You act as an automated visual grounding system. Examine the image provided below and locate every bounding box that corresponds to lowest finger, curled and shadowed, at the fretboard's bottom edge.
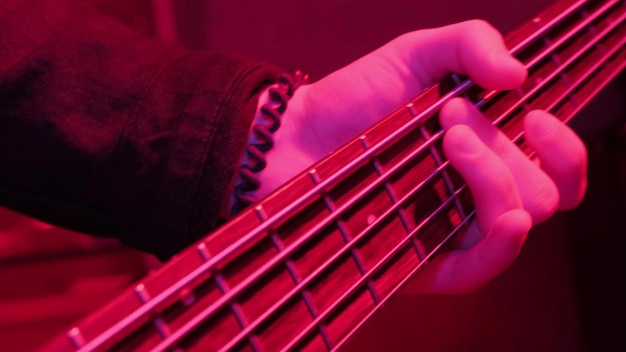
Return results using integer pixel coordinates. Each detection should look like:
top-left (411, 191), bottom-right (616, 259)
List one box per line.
top-left (405, 209), bottom-right (532, 294)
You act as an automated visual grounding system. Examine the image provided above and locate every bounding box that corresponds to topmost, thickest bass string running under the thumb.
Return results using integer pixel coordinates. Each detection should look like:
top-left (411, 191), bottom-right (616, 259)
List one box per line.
top-left (69, 1), bottom-right (615, 351)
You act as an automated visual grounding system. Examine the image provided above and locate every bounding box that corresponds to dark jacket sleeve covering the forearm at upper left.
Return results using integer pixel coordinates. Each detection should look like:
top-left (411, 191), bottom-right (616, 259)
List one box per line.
top-left (0, 0), bottom-right (279, 259)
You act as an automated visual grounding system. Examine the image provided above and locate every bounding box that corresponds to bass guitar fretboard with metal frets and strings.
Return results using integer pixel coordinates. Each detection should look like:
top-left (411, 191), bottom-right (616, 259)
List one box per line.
top-left (46, 0), bottom-right (626, 351)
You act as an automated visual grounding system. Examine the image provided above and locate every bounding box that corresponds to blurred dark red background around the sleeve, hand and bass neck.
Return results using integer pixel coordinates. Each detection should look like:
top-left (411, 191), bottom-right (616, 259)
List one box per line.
top-left (0, 0), bottom-right (626, 351)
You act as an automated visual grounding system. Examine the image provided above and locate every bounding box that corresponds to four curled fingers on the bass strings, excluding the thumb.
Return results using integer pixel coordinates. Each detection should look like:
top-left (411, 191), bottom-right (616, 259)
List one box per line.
top-left (407, 99), bottom-right (587, 293)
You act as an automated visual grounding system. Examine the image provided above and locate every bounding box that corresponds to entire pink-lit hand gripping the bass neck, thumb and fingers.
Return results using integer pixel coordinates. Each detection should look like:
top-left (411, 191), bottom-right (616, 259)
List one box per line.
top-left (252, 21), bottom-right (587, 293)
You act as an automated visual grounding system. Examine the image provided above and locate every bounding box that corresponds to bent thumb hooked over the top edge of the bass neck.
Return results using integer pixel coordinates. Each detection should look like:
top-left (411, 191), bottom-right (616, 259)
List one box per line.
top-left (399, 20), bottom-right (527, 90)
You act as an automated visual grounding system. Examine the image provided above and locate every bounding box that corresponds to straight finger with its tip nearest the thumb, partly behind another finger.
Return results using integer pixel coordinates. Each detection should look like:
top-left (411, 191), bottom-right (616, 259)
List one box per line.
top-left (440, 98), bottom-right (561, 224)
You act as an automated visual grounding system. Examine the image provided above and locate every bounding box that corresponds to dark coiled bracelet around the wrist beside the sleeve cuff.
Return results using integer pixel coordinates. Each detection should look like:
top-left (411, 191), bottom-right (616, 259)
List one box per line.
top-left (230, 70), bottom-right (308, 215)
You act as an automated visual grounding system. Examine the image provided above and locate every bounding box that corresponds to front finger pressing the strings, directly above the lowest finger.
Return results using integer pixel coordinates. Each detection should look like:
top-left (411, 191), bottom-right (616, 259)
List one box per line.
top-left (443, 125), bottom-right (522, 234)
